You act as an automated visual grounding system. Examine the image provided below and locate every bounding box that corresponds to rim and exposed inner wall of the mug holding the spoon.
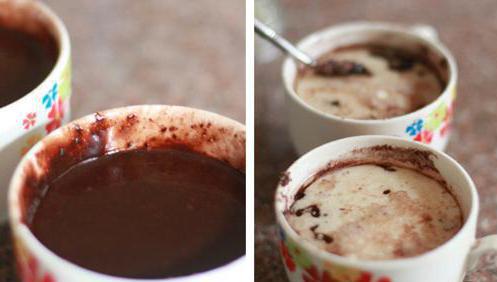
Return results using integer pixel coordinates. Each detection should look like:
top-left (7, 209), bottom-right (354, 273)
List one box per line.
top-left (282, 22), bottom-right (456, 123)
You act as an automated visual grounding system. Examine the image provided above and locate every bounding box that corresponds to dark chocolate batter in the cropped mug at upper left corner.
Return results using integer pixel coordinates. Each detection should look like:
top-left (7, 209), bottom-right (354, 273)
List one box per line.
top-left (0, 26), bottom-right (58, 107)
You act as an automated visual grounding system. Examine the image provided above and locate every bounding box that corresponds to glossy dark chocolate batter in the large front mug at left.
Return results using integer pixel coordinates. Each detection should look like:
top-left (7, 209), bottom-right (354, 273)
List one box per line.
top-left (28, 149), bottom-right (245, 278)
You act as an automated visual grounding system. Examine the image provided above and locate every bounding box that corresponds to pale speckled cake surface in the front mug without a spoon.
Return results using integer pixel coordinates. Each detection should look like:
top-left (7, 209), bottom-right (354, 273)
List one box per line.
top-left (286, 165), bottom-right (462, 260)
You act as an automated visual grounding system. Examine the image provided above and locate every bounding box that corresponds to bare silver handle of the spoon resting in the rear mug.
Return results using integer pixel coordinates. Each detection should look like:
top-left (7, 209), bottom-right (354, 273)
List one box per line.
top-left (254, 19), bottom-right (315, 66)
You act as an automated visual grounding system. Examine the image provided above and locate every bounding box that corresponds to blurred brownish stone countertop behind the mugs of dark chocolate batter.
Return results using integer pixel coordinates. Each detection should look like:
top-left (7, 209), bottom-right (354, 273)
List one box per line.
top-left (0, 0), bottom-right (245, 282)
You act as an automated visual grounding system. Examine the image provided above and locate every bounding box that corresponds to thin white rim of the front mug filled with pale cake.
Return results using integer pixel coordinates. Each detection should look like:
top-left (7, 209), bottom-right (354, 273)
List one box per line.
top-left (274, 135), bottom-right (479, 270)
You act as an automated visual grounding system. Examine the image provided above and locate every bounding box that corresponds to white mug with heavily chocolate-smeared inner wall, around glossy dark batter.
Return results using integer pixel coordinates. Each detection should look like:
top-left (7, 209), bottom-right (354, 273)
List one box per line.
top-left (8, 105), bottom-right (245, 282)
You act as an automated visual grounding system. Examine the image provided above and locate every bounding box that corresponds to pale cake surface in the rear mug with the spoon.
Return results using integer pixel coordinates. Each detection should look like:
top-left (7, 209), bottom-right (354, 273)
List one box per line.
top-left (295, 48), bottom-right (443, 119)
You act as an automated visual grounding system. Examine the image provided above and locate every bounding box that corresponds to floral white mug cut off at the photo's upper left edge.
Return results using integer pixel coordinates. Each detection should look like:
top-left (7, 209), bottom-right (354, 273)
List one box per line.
top-left (0, 0), bottom-right (71, 221)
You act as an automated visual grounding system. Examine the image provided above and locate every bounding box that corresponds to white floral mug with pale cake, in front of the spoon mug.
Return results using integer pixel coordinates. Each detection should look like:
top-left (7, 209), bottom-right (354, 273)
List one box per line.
top-left (275, 136), bottom-right (497, 282)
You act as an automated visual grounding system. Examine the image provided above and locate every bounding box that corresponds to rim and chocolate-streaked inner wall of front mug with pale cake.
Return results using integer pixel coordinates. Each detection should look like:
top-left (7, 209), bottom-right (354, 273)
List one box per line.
top-left (275, 136), bottom-right (478, 267)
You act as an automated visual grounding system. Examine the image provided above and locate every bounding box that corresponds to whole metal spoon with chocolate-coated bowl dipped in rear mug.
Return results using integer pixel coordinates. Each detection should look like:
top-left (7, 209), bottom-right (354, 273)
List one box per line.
top-left (254, 19), bottom-right (371, 76)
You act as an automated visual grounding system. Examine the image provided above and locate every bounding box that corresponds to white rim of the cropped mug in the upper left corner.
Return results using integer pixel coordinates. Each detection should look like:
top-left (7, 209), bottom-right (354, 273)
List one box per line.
top-left (0, 0), bottom-right (71, 112)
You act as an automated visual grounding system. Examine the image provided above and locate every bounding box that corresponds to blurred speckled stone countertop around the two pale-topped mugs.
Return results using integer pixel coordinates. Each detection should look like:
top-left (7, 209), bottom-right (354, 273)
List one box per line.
top-left (255, 0), bottom-right (497, 282)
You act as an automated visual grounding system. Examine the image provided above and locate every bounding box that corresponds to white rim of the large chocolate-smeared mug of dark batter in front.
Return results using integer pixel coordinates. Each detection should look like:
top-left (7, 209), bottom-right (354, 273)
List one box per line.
top-left (7, 104), bottom-right (247, 282)
